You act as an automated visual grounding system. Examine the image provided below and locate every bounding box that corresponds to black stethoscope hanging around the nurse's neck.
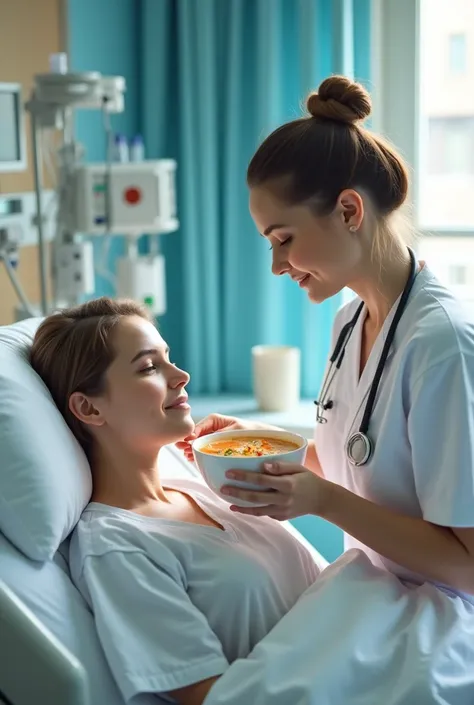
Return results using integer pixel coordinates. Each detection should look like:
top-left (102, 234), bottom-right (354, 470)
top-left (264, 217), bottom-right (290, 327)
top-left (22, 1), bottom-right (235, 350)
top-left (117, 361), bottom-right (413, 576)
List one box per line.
top-left (314, 248), bottom-right (417, 466)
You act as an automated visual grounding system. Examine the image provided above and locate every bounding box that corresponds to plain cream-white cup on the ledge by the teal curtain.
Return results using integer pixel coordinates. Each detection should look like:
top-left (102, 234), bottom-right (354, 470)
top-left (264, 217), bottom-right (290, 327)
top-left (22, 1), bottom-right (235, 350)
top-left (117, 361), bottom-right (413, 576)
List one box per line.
top-left (252, 345), bottom-right (301, 411)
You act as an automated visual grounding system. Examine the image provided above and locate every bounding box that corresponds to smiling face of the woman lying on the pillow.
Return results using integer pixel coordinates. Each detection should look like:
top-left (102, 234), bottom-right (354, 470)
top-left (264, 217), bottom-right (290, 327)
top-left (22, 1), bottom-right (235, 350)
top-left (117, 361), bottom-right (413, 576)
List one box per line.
top-left (90, 316), bottom-right (194, 451)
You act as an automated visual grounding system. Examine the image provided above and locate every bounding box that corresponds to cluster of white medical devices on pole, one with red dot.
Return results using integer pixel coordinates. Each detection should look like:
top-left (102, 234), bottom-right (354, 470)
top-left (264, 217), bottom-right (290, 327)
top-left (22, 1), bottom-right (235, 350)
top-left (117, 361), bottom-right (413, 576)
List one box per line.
top-left (0, 54), bottom-right (179, 319)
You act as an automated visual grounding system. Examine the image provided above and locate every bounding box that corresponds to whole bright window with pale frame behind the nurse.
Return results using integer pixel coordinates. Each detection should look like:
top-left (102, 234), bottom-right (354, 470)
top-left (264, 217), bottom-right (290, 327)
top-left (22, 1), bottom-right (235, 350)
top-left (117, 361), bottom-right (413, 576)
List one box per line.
top-left (372, 0), bottom-right (474, 311)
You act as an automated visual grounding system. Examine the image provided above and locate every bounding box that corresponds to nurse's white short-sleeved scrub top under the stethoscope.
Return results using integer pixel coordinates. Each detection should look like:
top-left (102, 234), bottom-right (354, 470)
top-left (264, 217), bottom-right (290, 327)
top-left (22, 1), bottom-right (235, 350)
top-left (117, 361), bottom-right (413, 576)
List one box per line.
top-left (315, 265), bottom-right (474, 592)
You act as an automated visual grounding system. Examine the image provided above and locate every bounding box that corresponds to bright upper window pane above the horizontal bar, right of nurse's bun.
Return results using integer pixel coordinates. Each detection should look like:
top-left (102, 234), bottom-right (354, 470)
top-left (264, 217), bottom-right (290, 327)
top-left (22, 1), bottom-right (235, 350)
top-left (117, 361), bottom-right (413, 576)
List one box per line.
top-left (416, 0), bottom-right (474, 231)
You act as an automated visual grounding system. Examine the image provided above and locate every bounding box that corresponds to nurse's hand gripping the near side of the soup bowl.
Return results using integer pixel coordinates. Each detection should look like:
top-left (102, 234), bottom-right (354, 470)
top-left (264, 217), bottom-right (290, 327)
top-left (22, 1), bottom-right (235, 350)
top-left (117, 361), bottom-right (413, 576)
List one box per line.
top-left (221, 463), bottom-right (331, 521)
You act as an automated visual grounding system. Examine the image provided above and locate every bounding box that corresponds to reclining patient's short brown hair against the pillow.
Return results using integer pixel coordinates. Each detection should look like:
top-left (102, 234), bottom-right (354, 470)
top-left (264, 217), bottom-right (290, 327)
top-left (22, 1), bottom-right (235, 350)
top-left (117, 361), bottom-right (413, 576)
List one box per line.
top-left (30, 296), bottom-right (150, 459)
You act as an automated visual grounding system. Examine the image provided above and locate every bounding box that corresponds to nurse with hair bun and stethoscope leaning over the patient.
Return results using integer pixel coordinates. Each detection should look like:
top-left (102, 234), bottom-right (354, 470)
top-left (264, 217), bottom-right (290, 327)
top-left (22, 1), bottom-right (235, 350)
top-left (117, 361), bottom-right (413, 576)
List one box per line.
top-left (180, 76), bottom-right (474, 705)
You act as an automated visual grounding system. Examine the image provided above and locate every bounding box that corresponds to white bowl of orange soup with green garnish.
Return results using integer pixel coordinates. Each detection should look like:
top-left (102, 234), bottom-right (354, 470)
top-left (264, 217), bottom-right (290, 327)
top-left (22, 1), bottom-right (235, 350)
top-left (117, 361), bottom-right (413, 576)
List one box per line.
top-left (193, 430), bottom-right (308, 507)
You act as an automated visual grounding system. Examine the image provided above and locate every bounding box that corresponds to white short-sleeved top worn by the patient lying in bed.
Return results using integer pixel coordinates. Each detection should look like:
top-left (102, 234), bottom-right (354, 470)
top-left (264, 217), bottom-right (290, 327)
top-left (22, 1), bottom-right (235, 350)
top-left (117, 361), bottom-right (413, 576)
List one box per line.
top-left (70, 480), bottom-right (319, 702)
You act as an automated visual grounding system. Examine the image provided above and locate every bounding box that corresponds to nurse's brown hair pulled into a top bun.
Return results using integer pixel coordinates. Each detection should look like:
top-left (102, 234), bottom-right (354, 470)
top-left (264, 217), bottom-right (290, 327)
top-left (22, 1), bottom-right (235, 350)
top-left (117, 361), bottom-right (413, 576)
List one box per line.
top-left (247, 76), bottom-right (408, 226)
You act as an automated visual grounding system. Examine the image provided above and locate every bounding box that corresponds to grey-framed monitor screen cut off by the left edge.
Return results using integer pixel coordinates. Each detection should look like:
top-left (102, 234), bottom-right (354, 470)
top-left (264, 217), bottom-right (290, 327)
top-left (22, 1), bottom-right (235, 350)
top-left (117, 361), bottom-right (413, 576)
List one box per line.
top-left (0, 83), bottom-right (26, 172)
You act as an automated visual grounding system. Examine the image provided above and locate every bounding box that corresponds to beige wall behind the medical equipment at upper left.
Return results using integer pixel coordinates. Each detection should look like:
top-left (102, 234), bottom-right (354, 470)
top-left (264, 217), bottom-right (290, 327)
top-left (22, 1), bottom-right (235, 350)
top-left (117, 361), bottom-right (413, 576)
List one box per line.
top-left (0, 0), bottom-right (66, 325)
